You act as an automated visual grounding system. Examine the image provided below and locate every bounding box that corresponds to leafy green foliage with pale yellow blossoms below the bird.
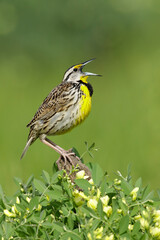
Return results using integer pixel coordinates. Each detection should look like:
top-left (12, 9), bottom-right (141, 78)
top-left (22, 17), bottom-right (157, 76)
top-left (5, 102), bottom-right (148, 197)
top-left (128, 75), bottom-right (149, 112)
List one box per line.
top-left (0, 163), bottom-right (160, 240)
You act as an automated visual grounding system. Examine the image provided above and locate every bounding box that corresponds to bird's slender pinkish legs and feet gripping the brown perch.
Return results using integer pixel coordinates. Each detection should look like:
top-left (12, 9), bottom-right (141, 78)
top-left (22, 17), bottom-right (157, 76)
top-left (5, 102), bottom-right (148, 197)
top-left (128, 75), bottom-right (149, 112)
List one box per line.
top-left (40, 138), bottom-right (75, 165)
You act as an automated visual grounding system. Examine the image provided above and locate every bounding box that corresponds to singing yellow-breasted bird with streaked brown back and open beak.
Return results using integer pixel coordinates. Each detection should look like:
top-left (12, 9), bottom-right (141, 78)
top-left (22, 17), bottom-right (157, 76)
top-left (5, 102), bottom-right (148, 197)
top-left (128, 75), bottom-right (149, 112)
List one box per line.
top-left (20, 59), bottom-right (101, 164)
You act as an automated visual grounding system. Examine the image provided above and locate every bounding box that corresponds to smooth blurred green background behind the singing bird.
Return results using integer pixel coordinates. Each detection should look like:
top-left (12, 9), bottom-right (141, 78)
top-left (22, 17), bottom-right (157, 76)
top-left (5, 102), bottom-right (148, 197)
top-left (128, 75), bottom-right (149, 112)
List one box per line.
top-left (0, 0), bottom-right (160, 194)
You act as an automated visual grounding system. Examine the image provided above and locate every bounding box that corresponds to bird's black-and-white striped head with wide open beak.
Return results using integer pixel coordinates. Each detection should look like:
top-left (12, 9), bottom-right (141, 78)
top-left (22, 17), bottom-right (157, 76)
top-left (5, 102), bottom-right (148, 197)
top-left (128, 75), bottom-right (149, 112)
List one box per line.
top-left (63, 59), bottom-right (101, 83)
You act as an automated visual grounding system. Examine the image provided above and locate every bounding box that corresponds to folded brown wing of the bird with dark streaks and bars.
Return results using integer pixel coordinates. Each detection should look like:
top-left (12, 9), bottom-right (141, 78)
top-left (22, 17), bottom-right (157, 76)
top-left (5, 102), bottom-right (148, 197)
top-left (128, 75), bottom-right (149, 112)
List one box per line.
top-left (27, 82), bottom-right (73, 127)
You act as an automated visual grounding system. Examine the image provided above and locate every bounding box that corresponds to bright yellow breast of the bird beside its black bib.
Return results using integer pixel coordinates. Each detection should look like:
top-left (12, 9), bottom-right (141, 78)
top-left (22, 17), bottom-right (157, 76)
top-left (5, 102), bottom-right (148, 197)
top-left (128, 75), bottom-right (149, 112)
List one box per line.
top-left (78, 85), bottom-right (91, 123)
